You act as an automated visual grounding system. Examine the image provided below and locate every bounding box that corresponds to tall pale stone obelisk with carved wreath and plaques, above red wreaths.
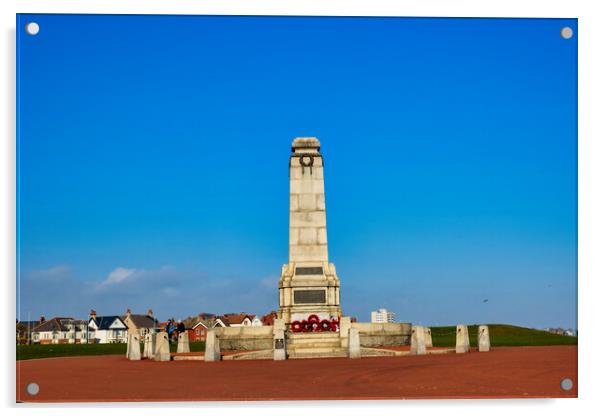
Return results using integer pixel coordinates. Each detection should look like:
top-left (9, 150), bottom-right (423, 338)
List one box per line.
top-left (279, 137), bottom-right (341, 324)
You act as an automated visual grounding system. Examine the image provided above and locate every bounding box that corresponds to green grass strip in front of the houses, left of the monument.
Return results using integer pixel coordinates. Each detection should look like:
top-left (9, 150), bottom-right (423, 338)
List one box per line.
top-left (17, 341), bottom-right (205, 360)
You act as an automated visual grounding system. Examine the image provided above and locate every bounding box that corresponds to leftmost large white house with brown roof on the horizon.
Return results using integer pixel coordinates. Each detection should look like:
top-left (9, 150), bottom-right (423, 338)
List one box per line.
top-left (31, 317), bottom-right (88, 344)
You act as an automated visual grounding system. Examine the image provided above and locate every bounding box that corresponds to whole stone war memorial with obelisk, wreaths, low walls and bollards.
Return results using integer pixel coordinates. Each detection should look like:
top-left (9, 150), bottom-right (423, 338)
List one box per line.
top-left (128, 137), bottom-right (489, 361)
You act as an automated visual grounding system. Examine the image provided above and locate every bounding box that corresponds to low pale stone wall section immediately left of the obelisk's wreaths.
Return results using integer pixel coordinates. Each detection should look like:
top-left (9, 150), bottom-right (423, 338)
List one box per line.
top-left (214, 326), bottom-right (274, 351)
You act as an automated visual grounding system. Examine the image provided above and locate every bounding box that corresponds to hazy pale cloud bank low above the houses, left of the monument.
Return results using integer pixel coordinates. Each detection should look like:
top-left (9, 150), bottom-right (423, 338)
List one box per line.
top-left (19, 265), bottom-right (278, 319)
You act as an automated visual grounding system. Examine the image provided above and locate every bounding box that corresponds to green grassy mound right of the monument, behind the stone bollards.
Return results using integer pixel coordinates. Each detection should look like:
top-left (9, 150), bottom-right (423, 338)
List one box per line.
top-left (431, 324), bottom-right (577, 347)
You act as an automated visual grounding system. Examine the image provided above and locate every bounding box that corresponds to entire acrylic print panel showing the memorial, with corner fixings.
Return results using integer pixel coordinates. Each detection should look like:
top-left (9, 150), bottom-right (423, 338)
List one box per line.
top-left (16, 14), bottom-right (578, 402)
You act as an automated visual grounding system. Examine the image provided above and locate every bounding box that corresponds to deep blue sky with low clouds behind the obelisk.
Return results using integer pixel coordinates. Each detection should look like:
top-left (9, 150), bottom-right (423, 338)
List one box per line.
top-left (17, 15), bottom-right (577, 327)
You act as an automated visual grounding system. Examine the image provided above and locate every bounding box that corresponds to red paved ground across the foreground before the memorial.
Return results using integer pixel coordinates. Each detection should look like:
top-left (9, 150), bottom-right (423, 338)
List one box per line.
top-left (17, 346), bottom-right (577, 402)
